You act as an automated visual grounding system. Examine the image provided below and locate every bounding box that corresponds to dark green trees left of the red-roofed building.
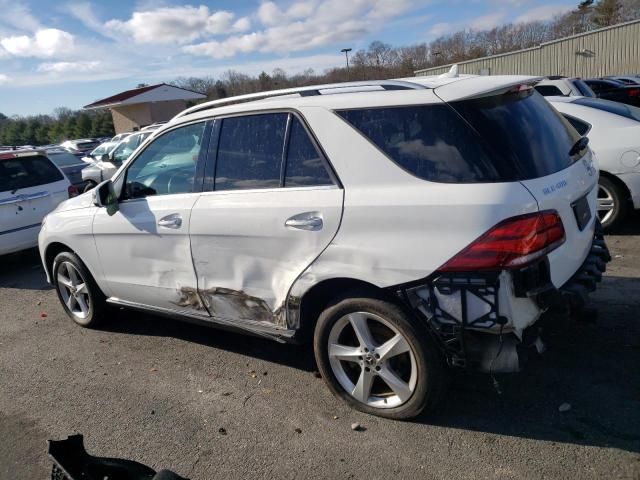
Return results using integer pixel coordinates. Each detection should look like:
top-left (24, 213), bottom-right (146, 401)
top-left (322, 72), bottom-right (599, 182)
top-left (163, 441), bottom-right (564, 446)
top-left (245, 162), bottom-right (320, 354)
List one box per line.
top-left (0, 108), bottom-right (114, 145)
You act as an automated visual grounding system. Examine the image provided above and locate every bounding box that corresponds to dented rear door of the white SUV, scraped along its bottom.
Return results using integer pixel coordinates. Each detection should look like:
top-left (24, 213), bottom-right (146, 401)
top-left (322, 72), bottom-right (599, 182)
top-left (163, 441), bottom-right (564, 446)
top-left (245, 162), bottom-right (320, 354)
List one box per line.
top-left (190, 112), bottom-right (343, 326)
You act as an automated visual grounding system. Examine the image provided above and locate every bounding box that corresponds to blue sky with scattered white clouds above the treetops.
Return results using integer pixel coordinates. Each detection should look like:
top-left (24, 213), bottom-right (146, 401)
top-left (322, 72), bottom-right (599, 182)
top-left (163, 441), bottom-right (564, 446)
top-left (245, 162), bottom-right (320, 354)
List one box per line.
top-left (0, 0), bottom-right (577, 116)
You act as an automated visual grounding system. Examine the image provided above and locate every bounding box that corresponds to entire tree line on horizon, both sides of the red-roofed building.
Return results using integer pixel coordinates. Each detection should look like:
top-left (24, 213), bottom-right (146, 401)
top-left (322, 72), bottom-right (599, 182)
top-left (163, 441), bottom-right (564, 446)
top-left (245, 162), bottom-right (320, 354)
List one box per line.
top-left (0, 0), bottom-right (640, 145)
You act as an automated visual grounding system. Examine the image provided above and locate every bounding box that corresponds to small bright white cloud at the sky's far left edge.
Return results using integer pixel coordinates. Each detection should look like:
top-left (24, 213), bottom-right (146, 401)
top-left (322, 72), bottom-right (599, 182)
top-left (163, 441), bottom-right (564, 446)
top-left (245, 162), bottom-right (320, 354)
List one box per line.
top-left (0, 28), bottom-right (74, 58)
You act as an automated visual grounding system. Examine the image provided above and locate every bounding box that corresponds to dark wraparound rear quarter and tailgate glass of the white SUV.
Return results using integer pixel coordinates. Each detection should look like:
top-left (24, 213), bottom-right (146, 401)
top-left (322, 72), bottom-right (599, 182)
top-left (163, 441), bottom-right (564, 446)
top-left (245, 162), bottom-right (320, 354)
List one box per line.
top-left (337, 89), bottom-right (580, 183)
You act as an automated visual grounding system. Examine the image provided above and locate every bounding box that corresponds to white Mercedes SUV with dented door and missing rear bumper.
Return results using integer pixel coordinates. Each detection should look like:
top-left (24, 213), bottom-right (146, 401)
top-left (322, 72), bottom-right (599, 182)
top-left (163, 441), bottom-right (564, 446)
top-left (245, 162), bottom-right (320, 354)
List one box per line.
top-left (40, 76), bottom-right (609, 418)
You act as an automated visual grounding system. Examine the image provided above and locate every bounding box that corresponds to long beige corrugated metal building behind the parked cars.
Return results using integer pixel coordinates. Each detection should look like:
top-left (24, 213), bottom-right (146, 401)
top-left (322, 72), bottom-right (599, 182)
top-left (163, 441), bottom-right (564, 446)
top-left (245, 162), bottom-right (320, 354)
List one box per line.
top-left (415, 20), bottom-right (640, 78)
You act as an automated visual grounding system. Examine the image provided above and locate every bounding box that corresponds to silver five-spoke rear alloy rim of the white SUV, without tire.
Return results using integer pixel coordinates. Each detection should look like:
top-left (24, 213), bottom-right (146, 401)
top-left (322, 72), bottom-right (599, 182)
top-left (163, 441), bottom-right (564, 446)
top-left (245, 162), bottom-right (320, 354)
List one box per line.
top-left (328, 312), bottom-right (418, 408)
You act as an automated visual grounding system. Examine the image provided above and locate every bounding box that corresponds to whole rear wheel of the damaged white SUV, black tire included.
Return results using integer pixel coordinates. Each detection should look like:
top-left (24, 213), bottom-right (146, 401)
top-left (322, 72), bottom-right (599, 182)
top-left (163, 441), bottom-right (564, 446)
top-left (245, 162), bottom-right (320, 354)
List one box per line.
top-left (313, 292), bottom-right (445, 420)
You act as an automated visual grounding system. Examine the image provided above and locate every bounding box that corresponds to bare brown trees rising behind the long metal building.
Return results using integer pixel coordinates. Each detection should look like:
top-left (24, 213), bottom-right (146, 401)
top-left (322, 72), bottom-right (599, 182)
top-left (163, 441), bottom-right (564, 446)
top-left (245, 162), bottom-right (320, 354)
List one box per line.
top-left (170, 0), bottom-right (640, 100)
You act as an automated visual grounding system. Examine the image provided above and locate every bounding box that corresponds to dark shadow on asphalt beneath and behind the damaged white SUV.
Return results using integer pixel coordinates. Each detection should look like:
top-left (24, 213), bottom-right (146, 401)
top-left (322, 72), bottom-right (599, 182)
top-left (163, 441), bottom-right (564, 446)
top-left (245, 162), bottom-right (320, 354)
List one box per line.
top-left (104, 277), bottom-right (640, 452)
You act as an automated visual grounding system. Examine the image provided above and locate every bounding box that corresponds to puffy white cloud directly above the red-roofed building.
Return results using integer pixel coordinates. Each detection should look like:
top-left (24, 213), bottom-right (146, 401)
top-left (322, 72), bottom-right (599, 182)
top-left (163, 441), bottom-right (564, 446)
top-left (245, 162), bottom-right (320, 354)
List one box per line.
top-left (105, 5), bottom-right (250, 44)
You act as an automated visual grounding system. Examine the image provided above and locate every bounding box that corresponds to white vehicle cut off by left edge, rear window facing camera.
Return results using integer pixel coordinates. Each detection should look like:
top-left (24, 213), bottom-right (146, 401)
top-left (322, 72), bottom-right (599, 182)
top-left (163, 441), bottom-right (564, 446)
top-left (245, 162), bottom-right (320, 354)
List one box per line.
top-left (0, 150), bottom-right (78, 255)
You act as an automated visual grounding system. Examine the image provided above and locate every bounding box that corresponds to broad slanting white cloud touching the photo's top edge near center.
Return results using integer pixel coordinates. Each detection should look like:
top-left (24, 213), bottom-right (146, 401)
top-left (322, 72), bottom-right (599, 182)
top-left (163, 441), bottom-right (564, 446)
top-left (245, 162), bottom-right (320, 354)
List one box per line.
top-left (183, 0), bottom-right (410, 59)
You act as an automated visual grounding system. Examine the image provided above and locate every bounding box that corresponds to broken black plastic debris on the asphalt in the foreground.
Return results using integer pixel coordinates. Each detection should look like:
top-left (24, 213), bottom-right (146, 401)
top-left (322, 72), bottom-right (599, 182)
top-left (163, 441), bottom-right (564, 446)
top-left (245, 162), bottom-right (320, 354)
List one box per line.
top-left (49, 435), bottom-right (188, 480)
